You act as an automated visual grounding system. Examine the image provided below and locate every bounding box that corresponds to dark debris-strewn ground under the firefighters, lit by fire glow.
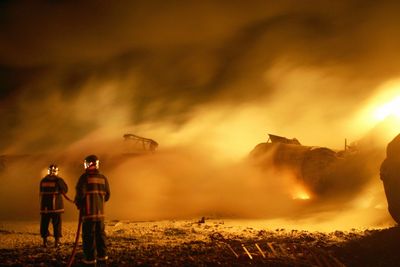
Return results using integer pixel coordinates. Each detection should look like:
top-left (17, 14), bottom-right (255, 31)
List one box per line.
top-left (0, 220), bottom-right (400, 267)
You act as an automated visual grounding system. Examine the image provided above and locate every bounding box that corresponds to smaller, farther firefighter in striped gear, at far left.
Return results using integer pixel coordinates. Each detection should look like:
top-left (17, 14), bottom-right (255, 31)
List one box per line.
top-left (40, 164), bottom-right (68, 247)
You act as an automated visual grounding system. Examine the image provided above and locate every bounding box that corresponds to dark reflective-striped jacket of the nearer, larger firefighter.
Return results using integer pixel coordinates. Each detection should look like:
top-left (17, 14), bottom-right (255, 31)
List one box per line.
top-left (75, 168), bottom-right (110, 221)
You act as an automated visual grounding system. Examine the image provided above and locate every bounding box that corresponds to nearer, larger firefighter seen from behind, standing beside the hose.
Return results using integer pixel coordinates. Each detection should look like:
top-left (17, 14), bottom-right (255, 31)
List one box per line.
top-left (75, 155), bottom-right (110, 265)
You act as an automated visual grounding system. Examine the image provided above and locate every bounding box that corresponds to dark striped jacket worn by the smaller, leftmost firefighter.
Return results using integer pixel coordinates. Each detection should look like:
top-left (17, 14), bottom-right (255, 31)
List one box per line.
top-left (39, 175), bottom-right (68, 214)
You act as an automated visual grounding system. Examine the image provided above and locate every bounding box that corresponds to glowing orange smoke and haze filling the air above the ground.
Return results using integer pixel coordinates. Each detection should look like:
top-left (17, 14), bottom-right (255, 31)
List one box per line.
top-left (0, 0), bottom-right (400, 230)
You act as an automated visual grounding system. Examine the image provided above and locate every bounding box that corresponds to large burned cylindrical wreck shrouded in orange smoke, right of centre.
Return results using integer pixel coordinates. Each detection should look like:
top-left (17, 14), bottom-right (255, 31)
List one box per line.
top-left (250, 134), bottom-right (370, 197)
